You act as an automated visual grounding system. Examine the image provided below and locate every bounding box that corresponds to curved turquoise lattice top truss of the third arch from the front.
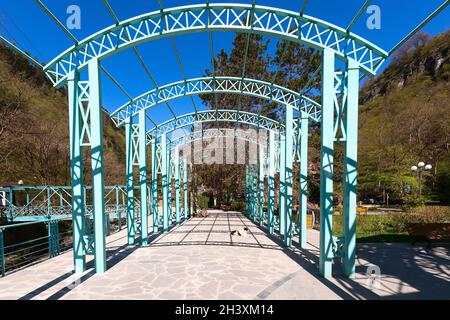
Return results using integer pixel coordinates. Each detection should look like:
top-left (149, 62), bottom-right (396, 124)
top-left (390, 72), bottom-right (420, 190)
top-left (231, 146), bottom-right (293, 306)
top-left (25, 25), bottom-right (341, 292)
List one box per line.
top-left (147, 109), bottom-right (284, 144)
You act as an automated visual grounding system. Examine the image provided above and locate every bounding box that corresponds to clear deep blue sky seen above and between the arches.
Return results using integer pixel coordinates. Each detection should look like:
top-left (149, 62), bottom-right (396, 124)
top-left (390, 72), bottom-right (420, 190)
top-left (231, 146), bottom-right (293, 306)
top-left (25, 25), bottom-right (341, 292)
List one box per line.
top-left (0, 0), bottom-right (450, 126)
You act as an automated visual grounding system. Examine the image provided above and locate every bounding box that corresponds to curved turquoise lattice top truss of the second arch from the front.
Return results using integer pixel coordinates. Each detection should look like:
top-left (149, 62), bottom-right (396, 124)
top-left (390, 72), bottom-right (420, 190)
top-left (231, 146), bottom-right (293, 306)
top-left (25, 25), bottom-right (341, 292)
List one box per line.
top-left (111, 76), bottom-right (320, 126)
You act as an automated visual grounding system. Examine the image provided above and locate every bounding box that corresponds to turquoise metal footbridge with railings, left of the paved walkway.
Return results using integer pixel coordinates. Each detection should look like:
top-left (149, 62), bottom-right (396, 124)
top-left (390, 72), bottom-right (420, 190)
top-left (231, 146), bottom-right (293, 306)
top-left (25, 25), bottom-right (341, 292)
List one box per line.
top-left (0, 186), bottom-right (146, 276)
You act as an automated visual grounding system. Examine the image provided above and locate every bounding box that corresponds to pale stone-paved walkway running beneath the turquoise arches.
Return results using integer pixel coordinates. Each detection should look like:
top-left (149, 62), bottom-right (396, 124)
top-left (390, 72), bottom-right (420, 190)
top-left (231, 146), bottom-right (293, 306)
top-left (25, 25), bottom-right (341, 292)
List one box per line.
top-left (0, 212), bottom-right (450, 299)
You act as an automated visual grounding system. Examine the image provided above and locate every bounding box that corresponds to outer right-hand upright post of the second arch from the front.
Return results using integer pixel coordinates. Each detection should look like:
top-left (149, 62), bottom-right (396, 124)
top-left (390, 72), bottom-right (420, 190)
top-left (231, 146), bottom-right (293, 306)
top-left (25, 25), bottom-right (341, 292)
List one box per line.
top-left (299, 112), bottom-right (309, 248)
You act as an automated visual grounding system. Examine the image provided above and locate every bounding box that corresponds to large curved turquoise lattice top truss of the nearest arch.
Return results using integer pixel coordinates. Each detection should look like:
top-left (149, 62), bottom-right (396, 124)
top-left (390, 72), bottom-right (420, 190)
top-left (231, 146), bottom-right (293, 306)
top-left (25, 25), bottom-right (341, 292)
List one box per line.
top-left (44, 3), bottom-right (388, 86)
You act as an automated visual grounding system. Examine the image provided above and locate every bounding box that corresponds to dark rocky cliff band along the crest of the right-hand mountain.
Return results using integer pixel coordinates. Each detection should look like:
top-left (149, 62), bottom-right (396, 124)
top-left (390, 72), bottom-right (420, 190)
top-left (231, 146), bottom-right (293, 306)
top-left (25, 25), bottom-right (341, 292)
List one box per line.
top-left (360, 31), bottom-right (450, 104)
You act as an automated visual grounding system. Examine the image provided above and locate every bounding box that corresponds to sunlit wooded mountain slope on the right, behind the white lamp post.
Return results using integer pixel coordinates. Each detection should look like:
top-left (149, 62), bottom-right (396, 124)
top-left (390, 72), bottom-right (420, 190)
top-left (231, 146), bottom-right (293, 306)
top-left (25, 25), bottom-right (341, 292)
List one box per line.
top-left (358, 32), bottom-right (450, 200)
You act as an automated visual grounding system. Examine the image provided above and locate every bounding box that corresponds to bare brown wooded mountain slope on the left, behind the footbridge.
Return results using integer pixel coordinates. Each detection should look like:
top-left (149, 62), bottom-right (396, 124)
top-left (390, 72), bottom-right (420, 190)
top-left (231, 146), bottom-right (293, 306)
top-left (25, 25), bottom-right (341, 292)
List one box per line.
top-left (0, 45), bottom-right (125, 185)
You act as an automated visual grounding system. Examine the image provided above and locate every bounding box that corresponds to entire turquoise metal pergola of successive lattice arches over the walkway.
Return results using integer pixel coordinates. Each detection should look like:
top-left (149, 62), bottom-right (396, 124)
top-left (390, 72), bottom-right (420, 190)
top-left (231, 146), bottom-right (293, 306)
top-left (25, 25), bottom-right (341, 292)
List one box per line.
top-left (2, 0), bottom-right (449, 278)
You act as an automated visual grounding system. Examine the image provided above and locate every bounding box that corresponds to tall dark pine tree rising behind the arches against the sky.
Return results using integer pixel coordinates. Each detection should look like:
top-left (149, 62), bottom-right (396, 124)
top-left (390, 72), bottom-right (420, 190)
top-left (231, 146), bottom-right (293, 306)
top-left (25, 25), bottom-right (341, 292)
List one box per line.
top-left (194, 33), bottom-right (320, 208)
